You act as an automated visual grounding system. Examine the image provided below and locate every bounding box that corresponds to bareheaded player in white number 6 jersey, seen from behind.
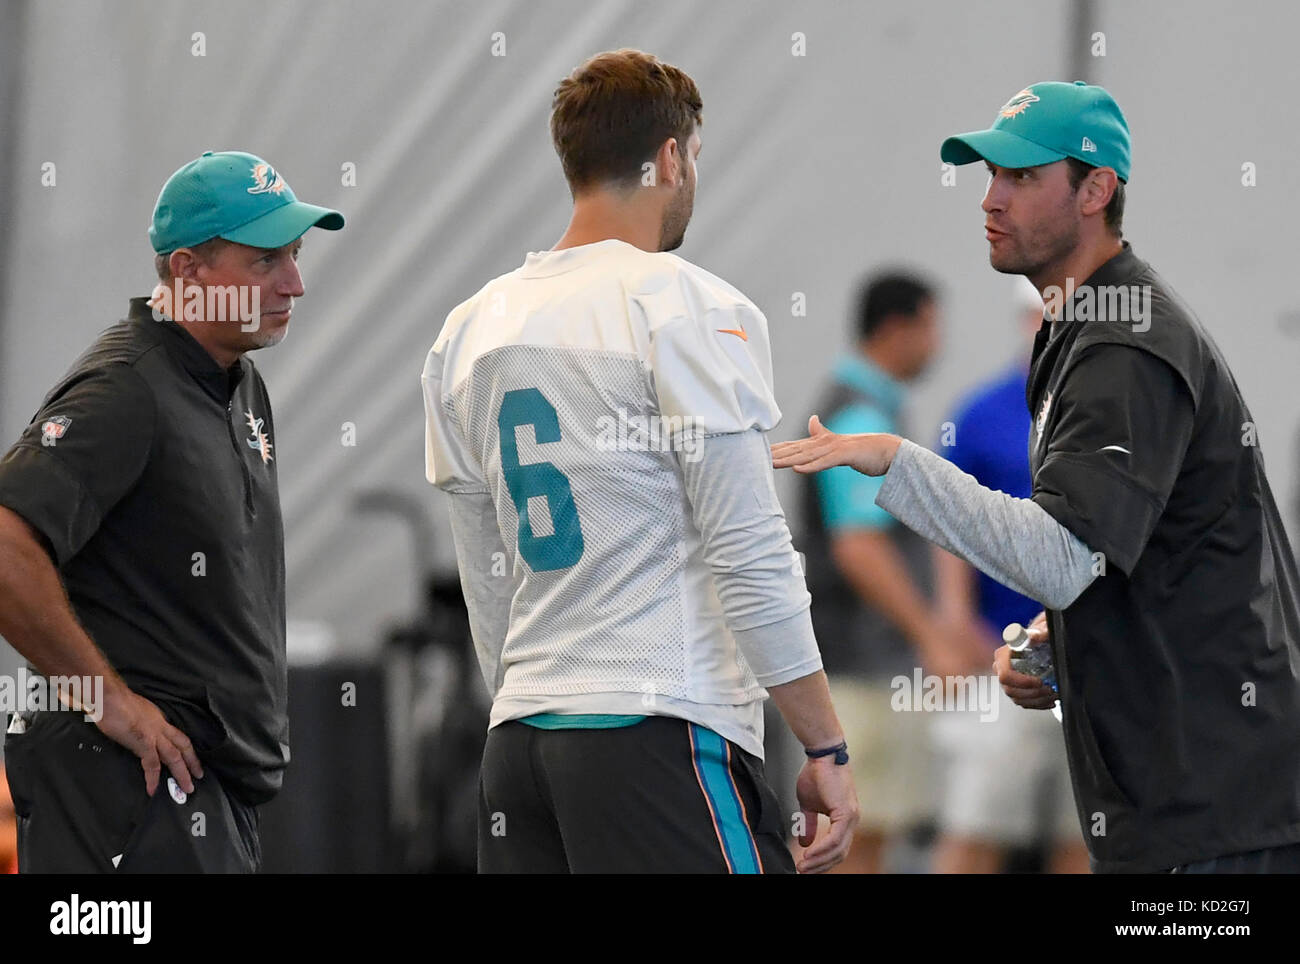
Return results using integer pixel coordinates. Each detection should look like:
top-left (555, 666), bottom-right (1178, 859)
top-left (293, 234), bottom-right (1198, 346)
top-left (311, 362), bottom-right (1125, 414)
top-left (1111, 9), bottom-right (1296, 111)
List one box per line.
top-left (423, 49), bottom-right (858, 873)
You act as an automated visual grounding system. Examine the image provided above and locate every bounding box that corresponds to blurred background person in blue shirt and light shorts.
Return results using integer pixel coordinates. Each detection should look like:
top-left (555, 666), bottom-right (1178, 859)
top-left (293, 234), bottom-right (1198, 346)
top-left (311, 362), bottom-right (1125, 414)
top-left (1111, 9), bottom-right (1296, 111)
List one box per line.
top-left (930, 277), bottom-right (1088, 873)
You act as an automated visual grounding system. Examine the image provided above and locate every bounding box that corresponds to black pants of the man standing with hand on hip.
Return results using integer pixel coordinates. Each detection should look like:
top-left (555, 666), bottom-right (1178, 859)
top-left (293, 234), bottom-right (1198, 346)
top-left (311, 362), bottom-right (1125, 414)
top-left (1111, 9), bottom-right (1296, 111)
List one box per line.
top-left (4, 712), bottom-right (261, 873)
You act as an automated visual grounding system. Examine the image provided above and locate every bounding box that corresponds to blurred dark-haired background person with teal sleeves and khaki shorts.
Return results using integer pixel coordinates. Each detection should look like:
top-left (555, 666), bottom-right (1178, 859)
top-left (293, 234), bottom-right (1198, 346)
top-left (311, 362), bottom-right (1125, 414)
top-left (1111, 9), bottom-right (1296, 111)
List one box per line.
top-left (803, 272), bottom-right (988, 873)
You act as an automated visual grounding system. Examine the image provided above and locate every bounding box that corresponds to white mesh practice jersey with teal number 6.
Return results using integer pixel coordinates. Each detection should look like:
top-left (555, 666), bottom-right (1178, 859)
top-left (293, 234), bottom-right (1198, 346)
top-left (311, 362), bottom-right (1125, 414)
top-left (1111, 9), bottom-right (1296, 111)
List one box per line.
top-left (424, 240), bottom-right (780, 756)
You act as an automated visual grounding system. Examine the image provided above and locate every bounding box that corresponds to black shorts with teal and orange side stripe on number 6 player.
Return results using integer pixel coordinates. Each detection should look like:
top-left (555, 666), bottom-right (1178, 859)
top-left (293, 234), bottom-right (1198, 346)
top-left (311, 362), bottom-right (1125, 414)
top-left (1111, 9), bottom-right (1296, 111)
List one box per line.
top-left (478, 716), bottom-right (794, 873)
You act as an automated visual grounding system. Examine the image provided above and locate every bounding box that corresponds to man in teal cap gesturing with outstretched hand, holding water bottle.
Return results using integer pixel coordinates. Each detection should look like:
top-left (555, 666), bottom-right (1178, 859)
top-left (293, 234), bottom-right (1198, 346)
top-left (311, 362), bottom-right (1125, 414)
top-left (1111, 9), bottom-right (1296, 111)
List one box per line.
top-left (772, 83), bottom-right (1300, 873)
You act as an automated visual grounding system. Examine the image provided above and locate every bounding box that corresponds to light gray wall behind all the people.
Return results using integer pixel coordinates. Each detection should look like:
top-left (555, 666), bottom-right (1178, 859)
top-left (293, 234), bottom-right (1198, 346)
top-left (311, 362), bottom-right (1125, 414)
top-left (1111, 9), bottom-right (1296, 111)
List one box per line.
top-left (0, 0), bottom-right (1300, 665)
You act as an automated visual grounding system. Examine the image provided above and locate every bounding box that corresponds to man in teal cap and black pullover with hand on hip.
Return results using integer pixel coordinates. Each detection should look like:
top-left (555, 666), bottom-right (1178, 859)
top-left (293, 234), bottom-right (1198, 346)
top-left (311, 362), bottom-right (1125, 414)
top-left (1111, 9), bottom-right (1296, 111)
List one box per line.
top-left (0, 152), bottom-right (343, 873)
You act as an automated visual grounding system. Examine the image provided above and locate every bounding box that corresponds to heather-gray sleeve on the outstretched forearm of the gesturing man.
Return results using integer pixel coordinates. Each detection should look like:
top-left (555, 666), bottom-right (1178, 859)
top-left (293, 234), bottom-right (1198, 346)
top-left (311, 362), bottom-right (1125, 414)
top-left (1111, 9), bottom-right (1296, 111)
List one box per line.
top-left (876, 439), bottom-right (1096, 611)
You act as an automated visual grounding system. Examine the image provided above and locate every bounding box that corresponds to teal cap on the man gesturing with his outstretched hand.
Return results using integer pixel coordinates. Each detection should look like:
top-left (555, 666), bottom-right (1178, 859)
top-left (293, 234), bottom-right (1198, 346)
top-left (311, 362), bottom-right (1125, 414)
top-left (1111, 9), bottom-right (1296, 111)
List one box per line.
top-left (939, 81), bottom-right (1131, 183)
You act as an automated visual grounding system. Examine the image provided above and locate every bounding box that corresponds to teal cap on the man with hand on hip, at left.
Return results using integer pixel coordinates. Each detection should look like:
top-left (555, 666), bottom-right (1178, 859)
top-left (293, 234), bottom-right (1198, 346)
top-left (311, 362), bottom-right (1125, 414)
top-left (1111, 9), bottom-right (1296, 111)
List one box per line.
top-left (150, 151), bottom-right (343, 255)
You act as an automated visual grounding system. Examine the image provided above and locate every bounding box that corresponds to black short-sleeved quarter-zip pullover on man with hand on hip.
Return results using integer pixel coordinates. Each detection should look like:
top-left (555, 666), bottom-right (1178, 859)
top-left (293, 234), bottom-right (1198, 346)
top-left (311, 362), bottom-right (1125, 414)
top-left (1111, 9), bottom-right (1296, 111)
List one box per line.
top-left (0, 298), bottom-right (289, 804)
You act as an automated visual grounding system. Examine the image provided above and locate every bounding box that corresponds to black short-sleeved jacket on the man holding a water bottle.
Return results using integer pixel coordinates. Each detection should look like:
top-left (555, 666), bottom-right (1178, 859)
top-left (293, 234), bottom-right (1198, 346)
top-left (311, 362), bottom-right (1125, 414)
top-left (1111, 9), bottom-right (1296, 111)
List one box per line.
top-left (1027, 244), bottom-right (1300, 872)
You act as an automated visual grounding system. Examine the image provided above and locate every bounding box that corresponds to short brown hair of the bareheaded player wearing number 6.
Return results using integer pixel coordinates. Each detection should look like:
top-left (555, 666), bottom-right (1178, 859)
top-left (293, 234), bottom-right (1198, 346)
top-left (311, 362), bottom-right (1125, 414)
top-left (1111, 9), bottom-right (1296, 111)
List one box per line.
top-left (551, 48), bottom-right (703, 194)
